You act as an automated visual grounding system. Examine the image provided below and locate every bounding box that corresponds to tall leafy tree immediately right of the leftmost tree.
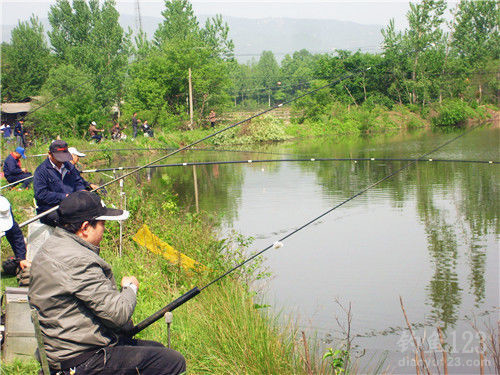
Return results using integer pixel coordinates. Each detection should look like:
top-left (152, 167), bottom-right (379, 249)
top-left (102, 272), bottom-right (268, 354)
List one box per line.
top-left (49, 0), bottom-right (130, 107)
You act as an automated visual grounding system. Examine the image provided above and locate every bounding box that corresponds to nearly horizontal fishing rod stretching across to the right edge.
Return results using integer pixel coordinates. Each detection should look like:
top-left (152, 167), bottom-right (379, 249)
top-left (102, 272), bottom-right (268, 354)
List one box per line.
top-left (81, 158), bottom-right (500, 173)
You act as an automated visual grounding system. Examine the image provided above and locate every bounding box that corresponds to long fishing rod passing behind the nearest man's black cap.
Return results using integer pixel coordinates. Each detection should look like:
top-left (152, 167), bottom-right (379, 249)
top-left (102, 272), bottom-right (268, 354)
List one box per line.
top-left (14, 67), bottom-right (364, 229)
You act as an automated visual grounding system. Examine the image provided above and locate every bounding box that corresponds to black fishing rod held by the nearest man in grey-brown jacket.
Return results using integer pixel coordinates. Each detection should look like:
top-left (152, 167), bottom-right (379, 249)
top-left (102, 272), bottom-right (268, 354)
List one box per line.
top-left (127, 124), bottom-right (480, 336)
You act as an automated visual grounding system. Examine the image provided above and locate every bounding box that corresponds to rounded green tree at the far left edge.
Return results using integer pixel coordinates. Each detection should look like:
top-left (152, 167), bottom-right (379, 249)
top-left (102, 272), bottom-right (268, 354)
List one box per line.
top-left (1, 16), bottom-right (51, 101)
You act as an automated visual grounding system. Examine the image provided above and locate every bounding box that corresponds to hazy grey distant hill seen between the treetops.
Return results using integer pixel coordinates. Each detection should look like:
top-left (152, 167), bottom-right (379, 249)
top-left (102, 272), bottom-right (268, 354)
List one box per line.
top-left (2, 14), bottom-right (382, 62)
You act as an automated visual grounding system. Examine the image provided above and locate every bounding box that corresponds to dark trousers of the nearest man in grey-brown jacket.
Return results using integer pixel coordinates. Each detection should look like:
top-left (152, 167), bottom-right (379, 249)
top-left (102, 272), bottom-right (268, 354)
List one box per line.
top-left (57, 338), bottom-right (186, 375)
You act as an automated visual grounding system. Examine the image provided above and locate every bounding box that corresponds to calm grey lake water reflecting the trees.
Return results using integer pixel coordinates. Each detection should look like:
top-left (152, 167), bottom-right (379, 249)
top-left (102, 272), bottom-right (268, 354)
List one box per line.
top-left (127, 128), bottom-right (500, 373)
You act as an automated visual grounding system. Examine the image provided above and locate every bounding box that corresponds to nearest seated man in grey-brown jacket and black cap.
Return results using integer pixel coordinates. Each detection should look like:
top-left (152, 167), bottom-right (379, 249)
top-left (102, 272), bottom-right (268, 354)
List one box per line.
top-left (28, 191), bottom-right (186, 375)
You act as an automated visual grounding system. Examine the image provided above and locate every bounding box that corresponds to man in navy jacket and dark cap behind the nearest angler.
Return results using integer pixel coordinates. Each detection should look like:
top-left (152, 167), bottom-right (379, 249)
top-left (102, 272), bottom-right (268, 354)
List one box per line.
top-left (33, 140), bottom-right (85, 226)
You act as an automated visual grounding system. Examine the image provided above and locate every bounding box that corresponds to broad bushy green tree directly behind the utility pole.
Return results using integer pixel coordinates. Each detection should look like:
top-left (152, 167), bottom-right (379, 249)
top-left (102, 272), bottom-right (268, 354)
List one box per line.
top-left (127, 0), bottom-right (233, 128)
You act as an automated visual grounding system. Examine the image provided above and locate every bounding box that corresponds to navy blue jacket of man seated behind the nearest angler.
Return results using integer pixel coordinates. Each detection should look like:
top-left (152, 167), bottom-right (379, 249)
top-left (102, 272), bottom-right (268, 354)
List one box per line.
top-left (33, 158), bottom-right (85, 214)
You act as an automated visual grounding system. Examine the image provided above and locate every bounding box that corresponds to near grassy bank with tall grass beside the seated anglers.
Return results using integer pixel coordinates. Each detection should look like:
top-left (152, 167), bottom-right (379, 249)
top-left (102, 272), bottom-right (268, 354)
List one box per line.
top-left (2, 165), bottom-right (316, 374)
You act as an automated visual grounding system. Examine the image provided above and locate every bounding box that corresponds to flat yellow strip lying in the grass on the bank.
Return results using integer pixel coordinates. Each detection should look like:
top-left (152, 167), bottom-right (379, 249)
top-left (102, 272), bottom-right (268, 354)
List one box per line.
top-left (132, 224), bottom-right (205, 270)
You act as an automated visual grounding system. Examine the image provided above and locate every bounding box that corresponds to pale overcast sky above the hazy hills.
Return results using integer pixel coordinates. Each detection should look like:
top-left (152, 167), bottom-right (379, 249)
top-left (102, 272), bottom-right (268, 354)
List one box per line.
top-left (1, 0), bottom-right (455, 29)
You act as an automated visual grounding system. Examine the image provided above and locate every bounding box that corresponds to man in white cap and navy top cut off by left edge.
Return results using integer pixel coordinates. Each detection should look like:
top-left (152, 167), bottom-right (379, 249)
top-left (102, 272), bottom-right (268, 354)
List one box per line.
top-left (0, 196), bottom-right (30, 275)
